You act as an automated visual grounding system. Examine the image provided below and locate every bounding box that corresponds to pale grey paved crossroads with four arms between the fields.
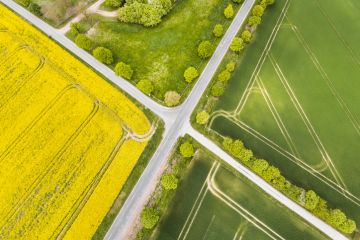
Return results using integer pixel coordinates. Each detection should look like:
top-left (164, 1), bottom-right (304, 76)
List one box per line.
top-left (0, 0), bottom-right (346, 239)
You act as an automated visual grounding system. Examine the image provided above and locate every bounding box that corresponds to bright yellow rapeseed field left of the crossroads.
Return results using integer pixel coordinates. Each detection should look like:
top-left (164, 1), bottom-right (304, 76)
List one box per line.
top-left (0, 4), bottom-right (151, 240)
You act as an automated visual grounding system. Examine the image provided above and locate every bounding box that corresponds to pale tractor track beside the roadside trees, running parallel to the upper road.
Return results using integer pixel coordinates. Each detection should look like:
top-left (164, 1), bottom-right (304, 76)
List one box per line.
top-left (234, 0), bottom-right (291, 115)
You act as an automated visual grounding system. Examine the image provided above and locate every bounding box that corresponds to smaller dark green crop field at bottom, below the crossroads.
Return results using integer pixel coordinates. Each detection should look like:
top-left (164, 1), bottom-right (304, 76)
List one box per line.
top-left (152, 156), bottom-right (326, 240)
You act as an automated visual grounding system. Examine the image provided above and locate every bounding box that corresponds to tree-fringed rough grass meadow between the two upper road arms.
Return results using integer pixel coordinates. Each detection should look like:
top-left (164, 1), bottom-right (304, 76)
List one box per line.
top-left (70, 0), bottom-right (238, 101)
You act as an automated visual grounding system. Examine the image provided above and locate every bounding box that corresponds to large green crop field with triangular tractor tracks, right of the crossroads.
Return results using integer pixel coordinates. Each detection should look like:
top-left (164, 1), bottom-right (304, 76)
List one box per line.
top-left (208, 0), bottom-right (360, 225)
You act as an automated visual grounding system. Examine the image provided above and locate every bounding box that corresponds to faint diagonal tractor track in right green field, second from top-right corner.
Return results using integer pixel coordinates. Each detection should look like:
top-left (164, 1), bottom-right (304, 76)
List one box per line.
top-left (288, 20), bottom-right (360, 136)
